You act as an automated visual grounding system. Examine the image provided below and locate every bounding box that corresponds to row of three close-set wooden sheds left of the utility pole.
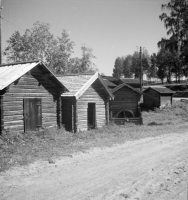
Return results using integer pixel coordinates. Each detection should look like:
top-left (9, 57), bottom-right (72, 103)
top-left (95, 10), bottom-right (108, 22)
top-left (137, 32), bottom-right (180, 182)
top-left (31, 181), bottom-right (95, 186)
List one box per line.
top-left (0, 61), bottom-right (141, 132)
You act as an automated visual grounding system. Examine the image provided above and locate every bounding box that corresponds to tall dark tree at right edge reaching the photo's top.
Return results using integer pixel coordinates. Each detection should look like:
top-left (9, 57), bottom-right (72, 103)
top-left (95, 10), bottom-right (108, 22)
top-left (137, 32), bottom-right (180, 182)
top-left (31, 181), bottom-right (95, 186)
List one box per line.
top-left (159, 0), bottom-right (188, 80)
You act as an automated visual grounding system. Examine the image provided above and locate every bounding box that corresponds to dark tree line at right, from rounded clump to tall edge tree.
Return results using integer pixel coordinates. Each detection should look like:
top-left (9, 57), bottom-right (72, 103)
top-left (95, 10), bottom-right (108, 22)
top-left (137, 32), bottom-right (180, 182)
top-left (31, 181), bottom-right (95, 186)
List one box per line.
top-left (113, 0), bottom-right (188, 83)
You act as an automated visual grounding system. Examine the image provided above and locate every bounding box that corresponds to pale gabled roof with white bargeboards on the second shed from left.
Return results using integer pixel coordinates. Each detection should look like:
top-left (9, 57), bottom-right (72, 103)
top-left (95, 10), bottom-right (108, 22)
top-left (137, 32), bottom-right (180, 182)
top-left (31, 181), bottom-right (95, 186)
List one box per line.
top-left (58, 72), bottom-right (114, 99)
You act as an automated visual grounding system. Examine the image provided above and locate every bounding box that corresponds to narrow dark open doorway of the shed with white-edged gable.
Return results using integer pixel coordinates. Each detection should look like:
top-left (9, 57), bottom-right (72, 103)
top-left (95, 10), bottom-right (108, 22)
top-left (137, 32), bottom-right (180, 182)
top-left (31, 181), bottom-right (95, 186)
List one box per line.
top-left (87, 103), bottom-right (96, 130)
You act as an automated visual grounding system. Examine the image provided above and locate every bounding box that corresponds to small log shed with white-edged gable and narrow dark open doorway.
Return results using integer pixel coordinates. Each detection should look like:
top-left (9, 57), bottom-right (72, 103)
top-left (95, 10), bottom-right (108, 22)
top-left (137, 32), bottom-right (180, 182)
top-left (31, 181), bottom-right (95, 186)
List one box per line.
top-left (59, 73), bottom-right (113, 132)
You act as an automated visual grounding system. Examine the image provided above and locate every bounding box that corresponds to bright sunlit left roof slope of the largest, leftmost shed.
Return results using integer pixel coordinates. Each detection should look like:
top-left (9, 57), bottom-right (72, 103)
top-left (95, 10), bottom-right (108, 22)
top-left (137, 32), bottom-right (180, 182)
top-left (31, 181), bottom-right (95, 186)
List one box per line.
top-left (0, 61), bottom-right (40, 90)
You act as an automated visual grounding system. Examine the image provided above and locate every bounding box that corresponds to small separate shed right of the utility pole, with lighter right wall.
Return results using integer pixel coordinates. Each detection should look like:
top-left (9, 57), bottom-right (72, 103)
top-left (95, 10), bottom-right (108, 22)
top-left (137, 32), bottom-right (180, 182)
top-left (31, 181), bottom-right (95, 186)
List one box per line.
top-left (143, 86), bottom-right (175, 109)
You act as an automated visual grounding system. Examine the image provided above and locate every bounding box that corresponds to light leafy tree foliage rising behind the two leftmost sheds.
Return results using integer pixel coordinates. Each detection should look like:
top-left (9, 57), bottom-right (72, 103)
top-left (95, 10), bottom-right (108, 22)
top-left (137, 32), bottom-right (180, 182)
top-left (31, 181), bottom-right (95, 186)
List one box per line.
top-left (4, 22), bottom-right (96, 74)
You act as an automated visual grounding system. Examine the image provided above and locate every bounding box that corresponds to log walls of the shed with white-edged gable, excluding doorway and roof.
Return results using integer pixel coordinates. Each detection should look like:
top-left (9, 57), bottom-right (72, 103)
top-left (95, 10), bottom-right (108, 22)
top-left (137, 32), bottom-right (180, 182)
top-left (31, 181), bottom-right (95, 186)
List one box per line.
top-left (61, 79), bottom-right (109, 132)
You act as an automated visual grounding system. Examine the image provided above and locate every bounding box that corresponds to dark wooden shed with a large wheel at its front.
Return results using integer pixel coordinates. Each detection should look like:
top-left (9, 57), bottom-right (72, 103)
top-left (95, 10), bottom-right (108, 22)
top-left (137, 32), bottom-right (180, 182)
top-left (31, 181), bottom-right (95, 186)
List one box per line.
top-left (110, 83), bottom-right (142, 124)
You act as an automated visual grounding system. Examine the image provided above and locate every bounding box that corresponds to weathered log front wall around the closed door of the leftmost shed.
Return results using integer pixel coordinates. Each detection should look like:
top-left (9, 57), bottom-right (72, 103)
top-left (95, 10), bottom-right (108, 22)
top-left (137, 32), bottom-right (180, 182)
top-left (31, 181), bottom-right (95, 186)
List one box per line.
top-left (3, 67), bottom-right (58, 131)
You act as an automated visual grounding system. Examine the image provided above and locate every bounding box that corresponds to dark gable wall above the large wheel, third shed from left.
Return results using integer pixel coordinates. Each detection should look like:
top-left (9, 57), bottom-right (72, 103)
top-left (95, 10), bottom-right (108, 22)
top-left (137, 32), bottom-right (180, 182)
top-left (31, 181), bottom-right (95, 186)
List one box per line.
top-left (110, 86), bottom-right (140, 117)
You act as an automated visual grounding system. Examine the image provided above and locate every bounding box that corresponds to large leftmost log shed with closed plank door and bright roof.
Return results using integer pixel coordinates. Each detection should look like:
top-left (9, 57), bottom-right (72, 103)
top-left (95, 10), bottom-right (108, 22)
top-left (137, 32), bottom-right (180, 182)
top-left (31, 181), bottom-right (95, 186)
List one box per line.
top-left (0, 61), bottom-right (66, 132)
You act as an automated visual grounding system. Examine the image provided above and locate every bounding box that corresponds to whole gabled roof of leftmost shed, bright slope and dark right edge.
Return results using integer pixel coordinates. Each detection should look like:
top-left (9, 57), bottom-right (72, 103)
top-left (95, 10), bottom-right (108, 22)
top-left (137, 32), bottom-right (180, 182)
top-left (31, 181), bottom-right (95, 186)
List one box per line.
top-left (0, 61), bottom-right (67, 90)
